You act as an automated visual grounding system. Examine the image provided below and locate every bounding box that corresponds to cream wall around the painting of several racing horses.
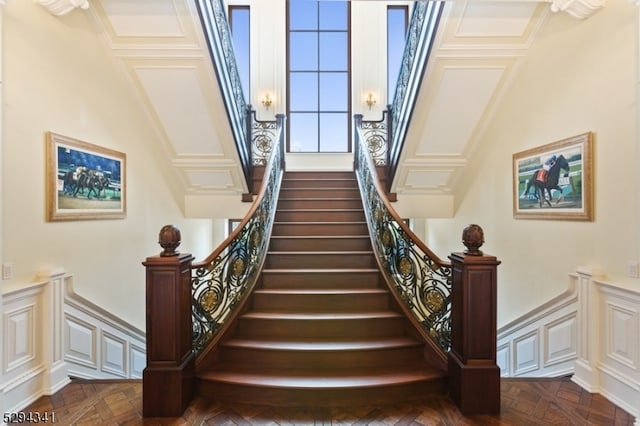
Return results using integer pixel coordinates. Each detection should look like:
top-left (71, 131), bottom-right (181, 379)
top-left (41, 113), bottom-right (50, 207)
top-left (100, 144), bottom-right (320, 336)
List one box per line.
top-left (1, 1), bottom-right (218, 329)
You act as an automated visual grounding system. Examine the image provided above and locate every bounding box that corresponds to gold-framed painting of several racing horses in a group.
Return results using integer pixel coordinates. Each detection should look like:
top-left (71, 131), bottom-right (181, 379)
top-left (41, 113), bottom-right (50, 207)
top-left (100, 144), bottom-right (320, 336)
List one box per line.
top-left (45, 132), bottom-right (127, 221)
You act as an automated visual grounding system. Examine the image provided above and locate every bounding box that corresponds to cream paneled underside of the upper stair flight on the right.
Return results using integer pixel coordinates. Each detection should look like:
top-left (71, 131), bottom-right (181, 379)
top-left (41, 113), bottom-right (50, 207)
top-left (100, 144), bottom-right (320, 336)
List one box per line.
top-left (392, 1), bottom-right (549, 194)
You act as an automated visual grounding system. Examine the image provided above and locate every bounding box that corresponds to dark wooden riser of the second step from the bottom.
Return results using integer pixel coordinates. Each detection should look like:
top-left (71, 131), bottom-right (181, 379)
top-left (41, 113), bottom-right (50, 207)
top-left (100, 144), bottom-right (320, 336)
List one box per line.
top-left (220, 346), bottom-right (422, 369)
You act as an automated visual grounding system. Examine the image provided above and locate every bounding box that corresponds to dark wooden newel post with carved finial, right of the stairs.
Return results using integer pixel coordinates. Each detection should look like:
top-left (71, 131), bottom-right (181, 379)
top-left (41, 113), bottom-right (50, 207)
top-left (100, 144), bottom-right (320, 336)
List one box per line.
top-left (448, 225), bottom-right (500, 414)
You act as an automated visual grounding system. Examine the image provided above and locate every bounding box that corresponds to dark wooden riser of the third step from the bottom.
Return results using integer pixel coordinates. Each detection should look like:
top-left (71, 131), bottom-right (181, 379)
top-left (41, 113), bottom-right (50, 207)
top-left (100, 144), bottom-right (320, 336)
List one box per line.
top-left (237, 317), bottom-right (403, 340)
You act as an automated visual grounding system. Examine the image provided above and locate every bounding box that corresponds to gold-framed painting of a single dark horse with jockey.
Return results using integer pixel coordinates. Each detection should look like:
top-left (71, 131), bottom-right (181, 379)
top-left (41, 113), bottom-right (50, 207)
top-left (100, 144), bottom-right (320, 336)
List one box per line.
top-left (513, 132), bottom-right (593, 221)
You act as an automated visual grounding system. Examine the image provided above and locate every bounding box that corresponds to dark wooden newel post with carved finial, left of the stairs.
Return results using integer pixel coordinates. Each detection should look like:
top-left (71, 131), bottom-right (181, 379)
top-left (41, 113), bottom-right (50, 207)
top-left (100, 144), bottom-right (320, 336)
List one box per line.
top-left (142, 225), bottom-right (194, 417)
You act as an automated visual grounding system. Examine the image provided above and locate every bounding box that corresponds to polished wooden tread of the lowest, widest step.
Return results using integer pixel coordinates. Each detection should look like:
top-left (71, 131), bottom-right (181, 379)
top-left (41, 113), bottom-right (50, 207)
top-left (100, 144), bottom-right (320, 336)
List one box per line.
top-left (198, 363), bottom-right (444, 389)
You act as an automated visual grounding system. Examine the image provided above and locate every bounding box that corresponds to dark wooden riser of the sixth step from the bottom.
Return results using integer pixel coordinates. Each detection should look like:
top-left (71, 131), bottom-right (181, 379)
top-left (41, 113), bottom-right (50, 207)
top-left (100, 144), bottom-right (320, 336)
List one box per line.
top-left (265, 252), bottom-right (377, 269)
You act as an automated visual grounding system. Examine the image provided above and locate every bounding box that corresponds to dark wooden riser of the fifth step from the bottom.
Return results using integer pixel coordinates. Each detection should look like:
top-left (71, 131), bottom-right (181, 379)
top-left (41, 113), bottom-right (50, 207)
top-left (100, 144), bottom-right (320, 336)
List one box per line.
top-left (260, 272), bottom-right (382, 289)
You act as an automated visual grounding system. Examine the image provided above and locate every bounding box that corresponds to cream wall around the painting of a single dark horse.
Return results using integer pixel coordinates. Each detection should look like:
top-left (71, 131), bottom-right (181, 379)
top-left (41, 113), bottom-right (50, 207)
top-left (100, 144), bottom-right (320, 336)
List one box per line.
top-left (427, 0), bottom-right (640, 326)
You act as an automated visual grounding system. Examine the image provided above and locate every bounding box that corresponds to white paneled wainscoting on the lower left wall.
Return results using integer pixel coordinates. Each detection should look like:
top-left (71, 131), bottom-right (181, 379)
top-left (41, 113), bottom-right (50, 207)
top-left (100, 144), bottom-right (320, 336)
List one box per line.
top-left (0, 268), bottom-right (146, 412)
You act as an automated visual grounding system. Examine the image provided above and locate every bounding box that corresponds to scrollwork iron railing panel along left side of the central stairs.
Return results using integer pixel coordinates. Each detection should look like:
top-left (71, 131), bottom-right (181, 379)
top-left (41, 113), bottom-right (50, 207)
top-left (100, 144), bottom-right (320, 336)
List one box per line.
top-left (191, 115), bottom-right (284, 355)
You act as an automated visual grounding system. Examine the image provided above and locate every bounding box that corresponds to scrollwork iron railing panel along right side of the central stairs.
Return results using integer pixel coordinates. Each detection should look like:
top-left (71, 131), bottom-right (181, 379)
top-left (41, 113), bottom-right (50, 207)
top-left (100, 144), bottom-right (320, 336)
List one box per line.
top-left (354, 115), bottom-right (452, 351)
